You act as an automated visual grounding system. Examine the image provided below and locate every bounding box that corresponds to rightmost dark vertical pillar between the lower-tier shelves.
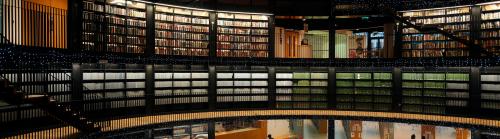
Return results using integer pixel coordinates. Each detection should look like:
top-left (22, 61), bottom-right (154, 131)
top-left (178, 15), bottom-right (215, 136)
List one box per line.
top-left (469, 67), bottom-right (485, 116)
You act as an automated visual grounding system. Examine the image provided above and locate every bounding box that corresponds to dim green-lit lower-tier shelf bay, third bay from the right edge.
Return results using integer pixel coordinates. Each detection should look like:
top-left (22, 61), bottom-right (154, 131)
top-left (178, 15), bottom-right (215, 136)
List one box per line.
top-left (336, 72), bottom-right (392, 111)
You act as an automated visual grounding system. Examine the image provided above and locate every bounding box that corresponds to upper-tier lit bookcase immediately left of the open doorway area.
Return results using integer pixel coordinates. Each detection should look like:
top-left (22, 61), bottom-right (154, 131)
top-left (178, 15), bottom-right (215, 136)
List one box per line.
top-left (217, 12), bottom-right (270, 57)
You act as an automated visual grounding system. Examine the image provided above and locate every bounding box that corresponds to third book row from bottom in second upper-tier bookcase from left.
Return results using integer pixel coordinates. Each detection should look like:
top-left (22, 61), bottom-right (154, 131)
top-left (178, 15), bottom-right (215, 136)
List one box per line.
top-left (155, 31), bottom-right (208, 41)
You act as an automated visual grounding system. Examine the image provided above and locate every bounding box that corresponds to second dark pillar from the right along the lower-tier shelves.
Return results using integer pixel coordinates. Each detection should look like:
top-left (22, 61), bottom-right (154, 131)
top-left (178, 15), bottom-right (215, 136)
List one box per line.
top-left (392, 67), bottom-right (403, 112)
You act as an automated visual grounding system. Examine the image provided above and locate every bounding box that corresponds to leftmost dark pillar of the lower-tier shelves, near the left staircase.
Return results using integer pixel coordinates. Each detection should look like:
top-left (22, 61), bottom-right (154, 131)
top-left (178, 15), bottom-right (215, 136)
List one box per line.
top-left (71, 63), bottom-right (83, 109)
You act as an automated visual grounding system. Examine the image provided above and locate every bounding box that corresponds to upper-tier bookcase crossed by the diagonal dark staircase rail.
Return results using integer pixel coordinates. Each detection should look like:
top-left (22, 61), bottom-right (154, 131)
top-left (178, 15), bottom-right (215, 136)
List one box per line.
top-left (401, 7), bottom-right (471, 57)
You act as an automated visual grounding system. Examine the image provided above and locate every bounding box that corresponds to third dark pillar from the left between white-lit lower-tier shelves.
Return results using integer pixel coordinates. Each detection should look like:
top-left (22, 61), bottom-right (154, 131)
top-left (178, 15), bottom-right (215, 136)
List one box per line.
top-left (208, 66), bottom-right (217, 110)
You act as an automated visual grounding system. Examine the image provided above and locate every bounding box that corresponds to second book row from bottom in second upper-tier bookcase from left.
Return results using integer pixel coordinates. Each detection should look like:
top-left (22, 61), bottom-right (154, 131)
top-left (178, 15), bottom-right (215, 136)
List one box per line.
top-left (155, 39), bottom-right (208, 48)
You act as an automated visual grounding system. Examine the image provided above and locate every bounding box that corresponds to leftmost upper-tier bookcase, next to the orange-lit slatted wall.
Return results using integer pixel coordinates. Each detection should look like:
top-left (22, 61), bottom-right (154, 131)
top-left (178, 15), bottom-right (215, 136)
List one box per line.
top-left (82, 0), bottom-right (146, 53)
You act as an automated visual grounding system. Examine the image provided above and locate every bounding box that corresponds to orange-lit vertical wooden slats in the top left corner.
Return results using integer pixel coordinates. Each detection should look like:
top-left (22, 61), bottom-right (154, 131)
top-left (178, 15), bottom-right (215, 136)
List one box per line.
top-left (1, 0), bottom-right (67, 49)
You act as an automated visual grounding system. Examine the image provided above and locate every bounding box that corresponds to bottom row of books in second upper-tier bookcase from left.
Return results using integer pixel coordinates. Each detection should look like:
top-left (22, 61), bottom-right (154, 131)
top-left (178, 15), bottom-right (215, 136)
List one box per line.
top-left (155, 47), bottom-right (208, 56)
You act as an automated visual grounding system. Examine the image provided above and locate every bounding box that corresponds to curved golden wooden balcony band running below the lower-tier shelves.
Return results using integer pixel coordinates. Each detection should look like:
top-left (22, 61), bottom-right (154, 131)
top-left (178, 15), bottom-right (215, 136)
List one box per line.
top-left (6, 110), bottom-right (500, 138)
